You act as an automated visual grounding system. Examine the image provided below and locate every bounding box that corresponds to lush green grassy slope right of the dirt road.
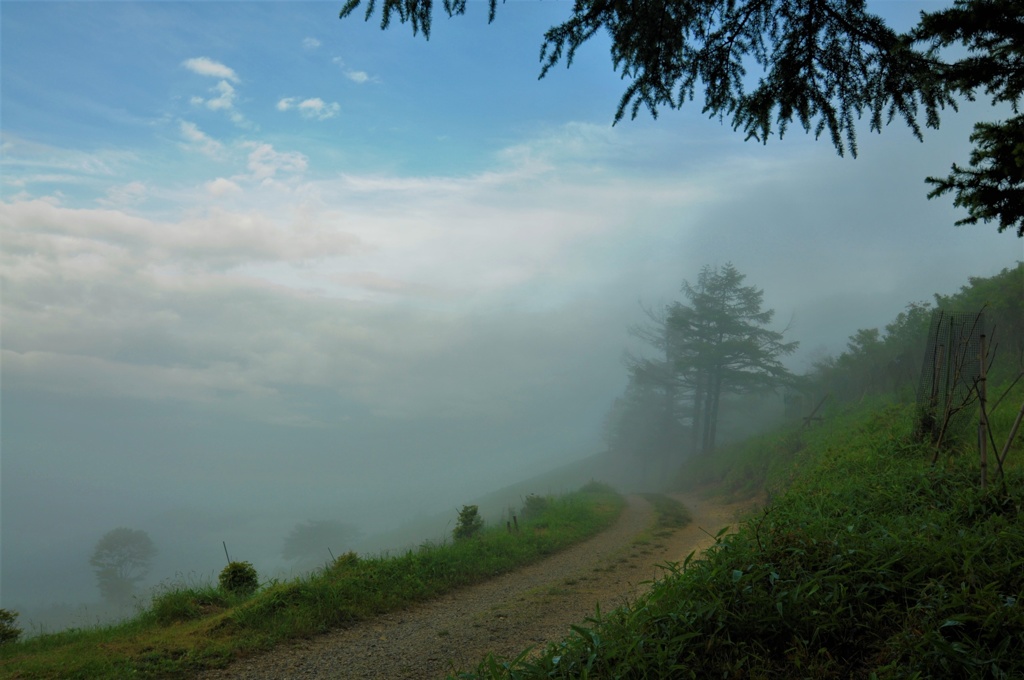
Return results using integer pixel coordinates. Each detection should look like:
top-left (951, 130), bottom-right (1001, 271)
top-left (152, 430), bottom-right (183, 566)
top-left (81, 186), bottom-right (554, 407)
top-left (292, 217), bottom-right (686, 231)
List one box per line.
top-left (459, 401), bottom-right (1024, 680)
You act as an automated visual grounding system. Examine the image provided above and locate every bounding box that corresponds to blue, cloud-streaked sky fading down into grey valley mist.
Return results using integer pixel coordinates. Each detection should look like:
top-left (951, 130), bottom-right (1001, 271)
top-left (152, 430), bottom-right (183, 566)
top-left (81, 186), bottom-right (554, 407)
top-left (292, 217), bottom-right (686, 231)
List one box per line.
top-left (0, 0), bottom-right (1024, 605)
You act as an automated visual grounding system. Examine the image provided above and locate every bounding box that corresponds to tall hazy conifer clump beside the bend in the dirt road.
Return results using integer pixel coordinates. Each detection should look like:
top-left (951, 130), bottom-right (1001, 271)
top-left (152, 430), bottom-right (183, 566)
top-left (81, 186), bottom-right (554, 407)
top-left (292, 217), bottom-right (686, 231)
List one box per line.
top-left (605, 263), bottom-right (798, 460)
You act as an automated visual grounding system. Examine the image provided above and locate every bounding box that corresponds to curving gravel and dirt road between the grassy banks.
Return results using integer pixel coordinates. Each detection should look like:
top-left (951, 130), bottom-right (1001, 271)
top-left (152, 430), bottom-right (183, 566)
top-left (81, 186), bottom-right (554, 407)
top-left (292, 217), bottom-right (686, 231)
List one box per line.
top-left (200, 495), bottom-right (759, 680)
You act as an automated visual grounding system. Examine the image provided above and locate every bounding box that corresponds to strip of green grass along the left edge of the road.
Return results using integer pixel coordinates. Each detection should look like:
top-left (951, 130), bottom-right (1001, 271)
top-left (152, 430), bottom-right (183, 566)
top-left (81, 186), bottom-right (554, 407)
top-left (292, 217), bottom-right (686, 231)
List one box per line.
top-left (0, 483), bottom-right (625, 680)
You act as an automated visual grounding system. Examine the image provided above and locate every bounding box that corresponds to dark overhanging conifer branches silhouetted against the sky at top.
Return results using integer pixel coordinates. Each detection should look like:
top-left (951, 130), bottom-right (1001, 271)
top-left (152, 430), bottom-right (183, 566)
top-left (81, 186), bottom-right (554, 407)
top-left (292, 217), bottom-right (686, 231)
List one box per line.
top-left (340, 0), bottom-right (1024, 237)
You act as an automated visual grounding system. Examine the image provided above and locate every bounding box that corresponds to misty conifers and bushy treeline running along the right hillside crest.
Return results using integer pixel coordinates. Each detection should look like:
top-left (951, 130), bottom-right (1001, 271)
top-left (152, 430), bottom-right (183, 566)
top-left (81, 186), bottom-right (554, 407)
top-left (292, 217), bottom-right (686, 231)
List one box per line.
top-left (604, 263), bottom-right (1024, 484)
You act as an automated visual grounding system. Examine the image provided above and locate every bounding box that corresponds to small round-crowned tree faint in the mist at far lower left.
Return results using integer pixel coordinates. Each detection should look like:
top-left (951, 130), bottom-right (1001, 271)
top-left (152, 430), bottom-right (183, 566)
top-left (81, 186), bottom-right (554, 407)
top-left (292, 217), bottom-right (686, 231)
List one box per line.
top-left (89, 526), bottom-right (157, 606)
